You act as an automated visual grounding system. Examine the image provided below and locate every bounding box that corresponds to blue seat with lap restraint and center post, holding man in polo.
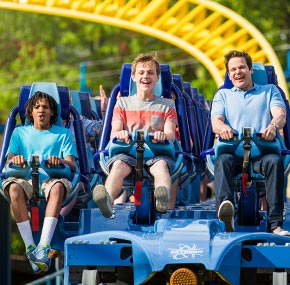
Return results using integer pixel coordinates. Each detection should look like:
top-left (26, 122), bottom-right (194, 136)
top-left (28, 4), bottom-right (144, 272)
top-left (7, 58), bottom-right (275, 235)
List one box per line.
top-left (201, 63), bottom-right (290, 231)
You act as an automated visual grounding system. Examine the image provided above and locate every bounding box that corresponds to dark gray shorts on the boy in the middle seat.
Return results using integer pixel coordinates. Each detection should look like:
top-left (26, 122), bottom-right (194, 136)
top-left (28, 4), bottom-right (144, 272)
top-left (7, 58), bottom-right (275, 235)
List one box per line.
top-left (107, 153), bottom-right (175, 173)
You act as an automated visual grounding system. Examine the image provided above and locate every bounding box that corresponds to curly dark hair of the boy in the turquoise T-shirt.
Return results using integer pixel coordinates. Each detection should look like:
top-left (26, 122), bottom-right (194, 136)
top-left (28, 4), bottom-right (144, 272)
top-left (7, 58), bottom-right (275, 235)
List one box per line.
top-left (25, 91), bottom-right (58, 124)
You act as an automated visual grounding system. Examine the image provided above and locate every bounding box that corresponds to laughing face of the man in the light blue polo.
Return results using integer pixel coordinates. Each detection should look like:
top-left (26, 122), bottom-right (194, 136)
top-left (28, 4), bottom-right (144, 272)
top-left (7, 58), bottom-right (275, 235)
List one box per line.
top-left (228, 57), bottom-right (253, 91)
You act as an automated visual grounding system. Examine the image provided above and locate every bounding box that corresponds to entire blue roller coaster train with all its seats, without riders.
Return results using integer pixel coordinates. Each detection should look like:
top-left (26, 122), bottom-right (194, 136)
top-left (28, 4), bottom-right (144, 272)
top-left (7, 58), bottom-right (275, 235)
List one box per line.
top-left (0, 63), bottom-right (290, 285)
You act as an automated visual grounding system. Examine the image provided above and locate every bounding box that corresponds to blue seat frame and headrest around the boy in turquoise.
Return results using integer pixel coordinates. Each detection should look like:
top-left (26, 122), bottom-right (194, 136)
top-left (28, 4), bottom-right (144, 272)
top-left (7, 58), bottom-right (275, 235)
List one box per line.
top-left (0, 82), bottom-right (89, 250)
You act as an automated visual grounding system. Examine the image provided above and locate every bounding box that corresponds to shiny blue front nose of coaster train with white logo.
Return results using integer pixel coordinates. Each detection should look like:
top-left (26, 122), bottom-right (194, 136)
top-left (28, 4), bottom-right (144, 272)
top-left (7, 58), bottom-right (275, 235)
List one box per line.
top-left (64, 62), bottom-right (290, 285)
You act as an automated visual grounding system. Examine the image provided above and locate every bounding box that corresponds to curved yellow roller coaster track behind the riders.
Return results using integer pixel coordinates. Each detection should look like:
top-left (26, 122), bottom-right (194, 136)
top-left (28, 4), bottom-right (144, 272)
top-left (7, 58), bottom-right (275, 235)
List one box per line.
top-left (0, 0), bottom-right (288, 98)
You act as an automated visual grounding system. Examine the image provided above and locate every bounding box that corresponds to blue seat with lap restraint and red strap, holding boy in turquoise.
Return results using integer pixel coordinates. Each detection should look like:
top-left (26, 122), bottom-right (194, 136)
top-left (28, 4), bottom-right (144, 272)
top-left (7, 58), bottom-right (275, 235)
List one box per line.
top-left (0, 82), bottom-right (90, 250)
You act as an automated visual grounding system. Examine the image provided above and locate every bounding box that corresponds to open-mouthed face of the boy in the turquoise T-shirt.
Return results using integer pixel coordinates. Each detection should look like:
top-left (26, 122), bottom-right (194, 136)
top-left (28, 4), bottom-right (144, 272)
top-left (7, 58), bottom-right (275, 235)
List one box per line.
top-left (31, 98), bottom-right (53, 130)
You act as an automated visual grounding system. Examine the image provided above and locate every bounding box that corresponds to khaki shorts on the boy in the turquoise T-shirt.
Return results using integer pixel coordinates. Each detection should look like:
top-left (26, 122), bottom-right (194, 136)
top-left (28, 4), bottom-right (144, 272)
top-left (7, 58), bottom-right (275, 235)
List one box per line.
top-left (3, 177), bottom-right (72, 200)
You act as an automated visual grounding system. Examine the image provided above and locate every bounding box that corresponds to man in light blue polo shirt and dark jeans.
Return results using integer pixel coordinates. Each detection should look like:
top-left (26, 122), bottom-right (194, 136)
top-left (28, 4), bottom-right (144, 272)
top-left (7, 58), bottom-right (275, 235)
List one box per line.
top-left (211, 50), bottom-right (290, 236)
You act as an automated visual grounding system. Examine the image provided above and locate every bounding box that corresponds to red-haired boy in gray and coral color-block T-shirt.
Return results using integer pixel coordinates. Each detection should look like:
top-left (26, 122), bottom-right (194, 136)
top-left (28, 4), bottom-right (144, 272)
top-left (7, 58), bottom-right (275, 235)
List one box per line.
top-left (93, 53), bottom-right (177, 218)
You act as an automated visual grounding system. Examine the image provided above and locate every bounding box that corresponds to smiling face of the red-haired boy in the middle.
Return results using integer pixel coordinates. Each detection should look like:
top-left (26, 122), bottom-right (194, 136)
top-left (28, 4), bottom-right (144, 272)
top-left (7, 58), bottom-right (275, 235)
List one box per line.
top-left (132, 61), bottom-right (159, 95)
